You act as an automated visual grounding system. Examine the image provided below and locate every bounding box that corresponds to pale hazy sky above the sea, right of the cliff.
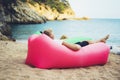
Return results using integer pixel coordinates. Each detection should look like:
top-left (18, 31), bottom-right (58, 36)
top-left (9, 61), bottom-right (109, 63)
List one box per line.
top-left (68, 0), bottom-right (120, 18)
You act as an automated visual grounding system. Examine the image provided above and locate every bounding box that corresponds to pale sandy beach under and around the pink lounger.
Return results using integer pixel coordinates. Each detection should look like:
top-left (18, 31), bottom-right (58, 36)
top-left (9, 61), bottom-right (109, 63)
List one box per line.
top-left (0, 41), bottom-right (120, 80)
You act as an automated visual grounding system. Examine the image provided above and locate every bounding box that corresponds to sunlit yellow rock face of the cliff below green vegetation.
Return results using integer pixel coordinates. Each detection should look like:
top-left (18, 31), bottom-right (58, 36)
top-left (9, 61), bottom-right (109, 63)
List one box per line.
top-left (28, 3), bottom-right (75, 20)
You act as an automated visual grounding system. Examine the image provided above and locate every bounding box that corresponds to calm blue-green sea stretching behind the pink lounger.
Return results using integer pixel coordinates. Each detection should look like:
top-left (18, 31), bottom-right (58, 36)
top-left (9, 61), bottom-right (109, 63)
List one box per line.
top-left (11, 19), bottom-right (120, 46)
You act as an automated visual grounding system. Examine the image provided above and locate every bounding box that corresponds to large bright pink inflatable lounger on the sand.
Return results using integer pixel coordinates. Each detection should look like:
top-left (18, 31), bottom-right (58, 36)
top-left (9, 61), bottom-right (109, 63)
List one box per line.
top-left (25, 34), bottom-right (110, 69)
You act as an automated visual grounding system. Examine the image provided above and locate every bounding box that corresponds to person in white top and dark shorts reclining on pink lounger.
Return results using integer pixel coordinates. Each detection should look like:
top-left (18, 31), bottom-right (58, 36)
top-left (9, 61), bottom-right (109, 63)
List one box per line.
top-left (41, 29), bottom-right (109, 51)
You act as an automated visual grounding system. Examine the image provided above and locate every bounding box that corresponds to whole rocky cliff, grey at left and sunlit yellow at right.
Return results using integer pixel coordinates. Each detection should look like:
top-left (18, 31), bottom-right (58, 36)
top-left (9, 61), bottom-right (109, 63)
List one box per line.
top-left (0, 0), bottom-right (75, 39)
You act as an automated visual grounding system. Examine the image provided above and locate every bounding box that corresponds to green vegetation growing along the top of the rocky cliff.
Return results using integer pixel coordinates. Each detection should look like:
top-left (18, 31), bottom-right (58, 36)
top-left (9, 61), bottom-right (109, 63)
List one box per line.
top-left (3, 0), bottom-right (70, 13)
